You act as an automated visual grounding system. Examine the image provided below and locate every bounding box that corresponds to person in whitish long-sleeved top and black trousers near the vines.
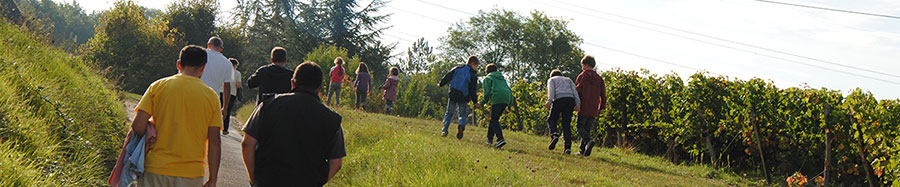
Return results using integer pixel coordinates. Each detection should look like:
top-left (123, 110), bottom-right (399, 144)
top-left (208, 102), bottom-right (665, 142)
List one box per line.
top-left (544, 69), bottom-right (581, 154)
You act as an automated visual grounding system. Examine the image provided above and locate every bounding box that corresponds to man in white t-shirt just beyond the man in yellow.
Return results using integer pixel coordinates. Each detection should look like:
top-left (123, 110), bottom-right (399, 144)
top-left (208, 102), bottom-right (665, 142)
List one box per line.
top-left (200, 36), bottom-right (234, 135)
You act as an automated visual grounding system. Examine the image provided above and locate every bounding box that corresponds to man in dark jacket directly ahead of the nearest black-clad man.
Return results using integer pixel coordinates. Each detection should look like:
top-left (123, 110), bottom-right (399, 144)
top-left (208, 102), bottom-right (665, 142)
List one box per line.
top-left (247, 47), bottom-right (294, 104)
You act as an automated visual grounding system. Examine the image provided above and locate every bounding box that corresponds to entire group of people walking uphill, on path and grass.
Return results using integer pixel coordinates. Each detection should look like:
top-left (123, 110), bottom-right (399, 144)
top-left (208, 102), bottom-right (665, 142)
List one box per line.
top-left (109, 37), bottom-right (606, 186)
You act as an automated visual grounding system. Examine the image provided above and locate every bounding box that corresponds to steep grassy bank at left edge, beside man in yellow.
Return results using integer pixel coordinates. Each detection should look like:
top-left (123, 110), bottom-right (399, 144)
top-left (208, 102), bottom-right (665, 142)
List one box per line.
top-left (0, 21), bottom-right (125, 186)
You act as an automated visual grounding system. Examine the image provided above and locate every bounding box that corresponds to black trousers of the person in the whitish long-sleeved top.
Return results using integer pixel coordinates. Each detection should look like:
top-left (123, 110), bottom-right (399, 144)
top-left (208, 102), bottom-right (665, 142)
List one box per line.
top-left (547, 97), bottom-right (575, 149)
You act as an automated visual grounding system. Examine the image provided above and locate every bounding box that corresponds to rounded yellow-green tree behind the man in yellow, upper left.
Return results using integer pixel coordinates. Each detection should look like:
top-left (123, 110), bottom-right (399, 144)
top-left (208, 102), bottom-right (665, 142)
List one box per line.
top-left (83, 1), bottom-right (180, 93)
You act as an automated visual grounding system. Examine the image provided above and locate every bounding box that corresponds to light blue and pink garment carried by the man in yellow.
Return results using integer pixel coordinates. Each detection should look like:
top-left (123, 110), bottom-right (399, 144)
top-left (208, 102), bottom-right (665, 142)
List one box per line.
top-left (119, 132), bottom-right (147, 187)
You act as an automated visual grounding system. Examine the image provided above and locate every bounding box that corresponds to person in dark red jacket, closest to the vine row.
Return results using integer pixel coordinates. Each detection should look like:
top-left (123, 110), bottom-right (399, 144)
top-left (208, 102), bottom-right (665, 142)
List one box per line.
top-left (575, 55), bottom-right (606, 156)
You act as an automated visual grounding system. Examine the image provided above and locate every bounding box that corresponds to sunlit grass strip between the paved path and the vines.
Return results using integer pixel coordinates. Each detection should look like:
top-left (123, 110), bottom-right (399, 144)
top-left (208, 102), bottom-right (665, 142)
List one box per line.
top-left (238, 105), bottom-right (759, 186)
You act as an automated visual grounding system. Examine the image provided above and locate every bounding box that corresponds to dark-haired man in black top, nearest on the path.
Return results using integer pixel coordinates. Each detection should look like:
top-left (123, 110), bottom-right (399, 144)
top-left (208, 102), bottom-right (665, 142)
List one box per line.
top-left (241, 62), bottom-right (347, 186)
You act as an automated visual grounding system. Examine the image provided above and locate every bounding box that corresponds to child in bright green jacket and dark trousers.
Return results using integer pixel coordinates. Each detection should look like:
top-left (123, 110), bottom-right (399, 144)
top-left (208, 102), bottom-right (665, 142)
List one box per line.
top-left (481, 64), bottom-right (515, 148)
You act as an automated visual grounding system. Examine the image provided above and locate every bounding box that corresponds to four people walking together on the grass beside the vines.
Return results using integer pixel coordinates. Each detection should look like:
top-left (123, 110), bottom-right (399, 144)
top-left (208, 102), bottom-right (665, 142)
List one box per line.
top-left (438, 55), bottom-right (606, 156)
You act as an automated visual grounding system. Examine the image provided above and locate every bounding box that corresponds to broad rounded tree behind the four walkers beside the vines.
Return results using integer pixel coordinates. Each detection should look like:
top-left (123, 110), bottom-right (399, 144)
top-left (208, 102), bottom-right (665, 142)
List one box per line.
top-left (441, 9), bottom-right (584, 81)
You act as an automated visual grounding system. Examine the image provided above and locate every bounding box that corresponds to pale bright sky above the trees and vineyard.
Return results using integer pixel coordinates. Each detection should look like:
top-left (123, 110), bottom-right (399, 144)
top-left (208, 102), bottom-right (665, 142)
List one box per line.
top-left (56, 0), bottom-right (900, 99)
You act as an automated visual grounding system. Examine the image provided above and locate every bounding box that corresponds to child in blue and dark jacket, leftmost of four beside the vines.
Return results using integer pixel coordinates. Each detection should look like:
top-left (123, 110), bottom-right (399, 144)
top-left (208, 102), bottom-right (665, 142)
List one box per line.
top-left (438, 55), bottom-right (481, 139)
